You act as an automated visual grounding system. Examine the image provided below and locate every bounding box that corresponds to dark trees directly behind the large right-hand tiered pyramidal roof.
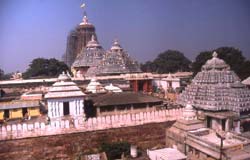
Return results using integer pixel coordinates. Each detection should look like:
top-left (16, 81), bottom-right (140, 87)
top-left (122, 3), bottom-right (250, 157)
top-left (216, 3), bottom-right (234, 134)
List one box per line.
top-left (192, 47), bottom-right (250, 80)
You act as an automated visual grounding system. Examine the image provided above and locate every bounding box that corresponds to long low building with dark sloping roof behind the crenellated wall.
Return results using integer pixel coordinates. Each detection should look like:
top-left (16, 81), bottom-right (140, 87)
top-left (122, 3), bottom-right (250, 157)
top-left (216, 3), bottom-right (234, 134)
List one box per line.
top-left (89, 92), bottom-right (163, 116)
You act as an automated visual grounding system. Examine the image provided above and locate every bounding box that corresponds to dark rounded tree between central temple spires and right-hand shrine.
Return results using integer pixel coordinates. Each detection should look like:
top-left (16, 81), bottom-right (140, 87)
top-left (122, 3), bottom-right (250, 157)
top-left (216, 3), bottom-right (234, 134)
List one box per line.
top-left (141, 50), bottom-right (191, 73)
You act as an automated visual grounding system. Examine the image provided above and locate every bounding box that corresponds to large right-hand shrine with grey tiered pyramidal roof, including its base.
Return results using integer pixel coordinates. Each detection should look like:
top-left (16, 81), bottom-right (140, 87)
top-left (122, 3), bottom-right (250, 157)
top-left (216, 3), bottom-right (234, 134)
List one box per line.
top-left (177, 52), bottom-right (250, 132)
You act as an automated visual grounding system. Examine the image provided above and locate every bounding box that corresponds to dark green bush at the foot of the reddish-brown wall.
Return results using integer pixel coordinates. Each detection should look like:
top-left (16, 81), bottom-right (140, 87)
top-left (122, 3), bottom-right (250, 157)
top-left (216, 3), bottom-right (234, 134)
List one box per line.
top-left (101, 142), bottom-right (130, 160)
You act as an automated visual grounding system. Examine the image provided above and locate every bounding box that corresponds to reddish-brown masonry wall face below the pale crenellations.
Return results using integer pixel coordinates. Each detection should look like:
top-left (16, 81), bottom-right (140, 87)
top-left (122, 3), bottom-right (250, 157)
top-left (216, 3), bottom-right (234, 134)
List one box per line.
top-left (0, 121), bottom-right (176, 160)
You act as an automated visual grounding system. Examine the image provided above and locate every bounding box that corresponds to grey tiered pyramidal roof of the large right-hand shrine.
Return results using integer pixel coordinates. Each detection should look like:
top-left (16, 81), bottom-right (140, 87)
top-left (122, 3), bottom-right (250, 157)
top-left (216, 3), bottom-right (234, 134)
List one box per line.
top-left (177, 53), bottom-right (250, 111)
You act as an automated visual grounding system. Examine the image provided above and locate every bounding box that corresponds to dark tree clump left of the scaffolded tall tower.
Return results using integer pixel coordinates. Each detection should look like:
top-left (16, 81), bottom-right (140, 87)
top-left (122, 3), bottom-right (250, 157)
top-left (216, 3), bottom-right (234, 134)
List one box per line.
top-left (23, 58), bottom-right (69, 78)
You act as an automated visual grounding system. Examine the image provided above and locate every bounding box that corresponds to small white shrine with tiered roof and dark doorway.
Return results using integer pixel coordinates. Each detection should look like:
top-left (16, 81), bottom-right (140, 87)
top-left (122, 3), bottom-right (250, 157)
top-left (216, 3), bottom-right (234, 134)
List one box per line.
top-left (45, 73), bottom-right (85, 119)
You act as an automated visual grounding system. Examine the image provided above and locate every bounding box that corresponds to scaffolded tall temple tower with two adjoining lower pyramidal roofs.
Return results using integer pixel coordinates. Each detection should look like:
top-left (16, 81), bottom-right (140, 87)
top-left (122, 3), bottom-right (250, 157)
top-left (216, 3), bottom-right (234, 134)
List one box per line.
top-left (63, 4), bottom-right (141, 77)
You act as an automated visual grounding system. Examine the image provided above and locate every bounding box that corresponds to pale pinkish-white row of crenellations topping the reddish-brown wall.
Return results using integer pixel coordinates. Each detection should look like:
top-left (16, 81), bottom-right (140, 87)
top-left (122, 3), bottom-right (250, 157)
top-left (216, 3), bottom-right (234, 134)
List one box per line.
top-left (0, 108), bottom-right (183, 140)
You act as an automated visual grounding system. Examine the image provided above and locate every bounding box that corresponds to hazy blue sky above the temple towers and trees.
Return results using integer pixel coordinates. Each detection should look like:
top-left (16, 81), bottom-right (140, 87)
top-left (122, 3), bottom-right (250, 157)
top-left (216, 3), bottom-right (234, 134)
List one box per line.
top-left (0, 0), bottom-right (250, 72)
